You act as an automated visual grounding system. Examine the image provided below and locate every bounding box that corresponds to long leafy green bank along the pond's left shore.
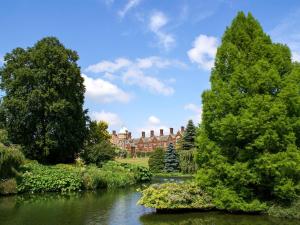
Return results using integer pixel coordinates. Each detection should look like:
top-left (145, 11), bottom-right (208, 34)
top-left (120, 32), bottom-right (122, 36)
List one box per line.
top-left (0, 161), bottom-right (151, 194)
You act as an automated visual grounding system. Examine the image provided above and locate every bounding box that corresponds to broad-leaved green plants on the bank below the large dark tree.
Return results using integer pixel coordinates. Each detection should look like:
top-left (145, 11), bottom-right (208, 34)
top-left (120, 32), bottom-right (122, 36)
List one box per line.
top-left (18, 162), bottom-right (82, 193)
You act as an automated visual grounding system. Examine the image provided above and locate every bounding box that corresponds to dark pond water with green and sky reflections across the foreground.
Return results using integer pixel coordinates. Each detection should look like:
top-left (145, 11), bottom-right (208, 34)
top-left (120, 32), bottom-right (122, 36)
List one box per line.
top-left (0, 181), bottom-right (300, 225)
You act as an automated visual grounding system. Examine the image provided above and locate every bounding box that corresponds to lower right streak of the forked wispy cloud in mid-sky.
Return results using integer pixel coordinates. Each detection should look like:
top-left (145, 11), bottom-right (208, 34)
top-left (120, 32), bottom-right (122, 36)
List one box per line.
top-left (123, 69), bottom-right (174, 96)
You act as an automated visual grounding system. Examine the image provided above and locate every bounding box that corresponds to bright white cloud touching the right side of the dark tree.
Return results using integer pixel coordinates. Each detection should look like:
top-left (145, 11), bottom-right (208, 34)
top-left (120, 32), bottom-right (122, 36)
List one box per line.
top-left (82, 74), bottom-right (131, 103)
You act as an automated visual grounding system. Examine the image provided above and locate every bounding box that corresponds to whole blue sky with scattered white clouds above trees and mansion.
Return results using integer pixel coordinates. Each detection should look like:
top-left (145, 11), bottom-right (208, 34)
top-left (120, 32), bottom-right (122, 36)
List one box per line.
top-left (0, 0), bottom-right (300, 137)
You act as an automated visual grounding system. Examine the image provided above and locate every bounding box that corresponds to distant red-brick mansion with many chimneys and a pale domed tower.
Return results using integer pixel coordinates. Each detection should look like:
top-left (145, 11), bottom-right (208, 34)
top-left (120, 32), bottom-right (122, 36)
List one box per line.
top-left (111, 127), bottom-right (184, 156)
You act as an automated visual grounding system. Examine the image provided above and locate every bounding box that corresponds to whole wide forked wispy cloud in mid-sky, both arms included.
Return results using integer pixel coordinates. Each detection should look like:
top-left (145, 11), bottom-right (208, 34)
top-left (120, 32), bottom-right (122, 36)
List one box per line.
top-left (85, 56), bottom-right (186, 96)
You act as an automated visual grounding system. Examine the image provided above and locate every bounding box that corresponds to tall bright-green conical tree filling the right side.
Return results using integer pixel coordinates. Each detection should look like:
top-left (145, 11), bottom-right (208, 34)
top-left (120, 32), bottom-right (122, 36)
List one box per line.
top-left (197, 12), bottom-right (300, 211)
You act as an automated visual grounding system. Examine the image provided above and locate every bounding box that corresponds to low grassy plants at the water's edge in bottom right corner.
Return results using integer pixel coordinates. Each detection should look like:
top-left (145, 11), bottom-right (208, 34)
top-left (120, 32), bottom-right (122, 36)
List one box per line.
top-left (268, 199), bottom-right (300, 219)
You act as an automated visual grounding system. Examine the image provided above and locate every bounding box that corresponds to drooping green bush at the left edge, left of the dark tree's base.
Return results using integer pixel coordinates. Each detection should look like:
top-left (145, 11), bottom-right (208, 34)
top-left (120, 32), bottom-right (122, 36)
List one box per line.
top-left (0, 143), bottom-right (25, 179)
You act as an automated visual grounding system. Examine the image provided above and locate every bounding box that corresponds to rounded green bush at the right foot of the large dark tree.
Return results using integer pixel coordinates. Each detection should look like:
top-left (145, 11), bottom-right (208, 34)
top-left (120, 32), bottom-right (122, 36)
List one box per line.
top-left (80, 140), bottom-right (116, 166)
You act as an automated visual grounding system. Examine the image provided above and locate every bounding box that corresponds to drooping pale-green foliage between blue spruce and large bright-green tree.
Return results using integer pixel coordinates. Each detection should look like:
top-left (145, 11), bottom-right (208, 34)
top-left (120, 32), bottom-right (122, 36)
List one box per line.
top-left (178, 149), bottom-right (198, 173)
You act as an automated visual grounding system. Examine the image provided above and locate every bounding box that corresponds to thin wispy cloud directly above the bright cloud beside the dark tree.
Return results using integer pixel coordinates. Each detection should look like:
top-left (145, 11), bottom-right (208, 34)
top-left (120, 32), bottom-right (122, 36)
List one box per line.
top-left (85, 58), bottom-right (131, 73)
